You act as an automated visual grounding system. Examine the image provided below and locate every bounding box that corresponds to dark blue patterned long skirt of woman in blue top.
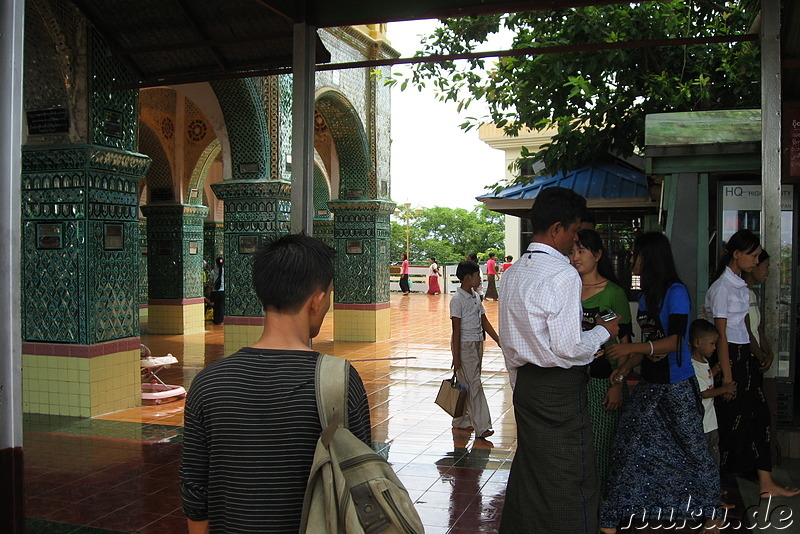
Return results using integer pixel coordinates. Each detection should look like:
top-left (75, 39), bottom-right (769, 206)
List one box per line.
top-left (600, 377), bottom-right (723, 528)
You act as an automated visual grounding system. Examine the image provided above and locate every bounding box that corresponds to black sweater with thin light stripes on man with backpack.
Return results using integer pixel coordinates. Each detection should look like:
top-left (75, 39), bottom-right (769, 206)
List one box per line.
top-left (180, 347), bottom-right (371, 533)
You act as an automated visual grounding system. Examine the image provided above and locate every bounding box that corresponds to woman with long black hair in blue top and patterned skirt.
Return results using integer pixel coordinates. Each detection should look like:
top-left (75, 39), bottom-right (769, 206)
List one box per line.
top-left (600, 232), bottom-right (723, 533)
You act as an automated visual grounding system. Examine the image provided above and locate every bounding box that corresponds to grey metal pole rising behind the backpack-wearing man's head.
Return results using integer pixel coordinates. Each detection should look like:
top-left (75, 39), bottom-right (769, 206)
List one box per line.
top-left (291, 23), bottom-right (317, 235)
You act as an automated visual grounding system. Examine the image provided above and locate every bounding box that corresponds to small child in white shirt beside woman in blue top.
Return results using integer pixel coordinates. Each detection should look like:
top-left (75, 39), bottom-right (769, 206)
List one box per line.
top-left (689, 319), bottom-right (736, 468)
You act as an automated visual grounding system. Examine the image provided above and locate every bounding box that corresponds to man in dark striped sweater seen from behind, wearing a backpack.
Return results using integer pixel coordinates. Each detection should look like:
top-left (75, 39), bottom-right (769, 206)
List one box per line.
top-left (180, 234), bottom-right (371, 534)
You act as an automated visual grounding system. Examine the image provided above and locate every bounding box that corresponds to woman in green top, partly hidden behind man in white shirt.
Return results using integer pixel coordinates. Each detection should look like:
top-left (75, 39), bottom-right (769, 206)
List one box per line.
top-left (570, 230), bottom-right (631, 495)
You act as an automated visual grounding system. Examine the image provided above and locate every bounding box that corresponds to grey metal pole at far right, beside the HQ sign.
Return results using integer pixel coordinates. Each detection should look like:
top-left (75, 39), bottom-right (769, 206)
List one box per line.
top-left (761, 0), bottom-right (786, 376)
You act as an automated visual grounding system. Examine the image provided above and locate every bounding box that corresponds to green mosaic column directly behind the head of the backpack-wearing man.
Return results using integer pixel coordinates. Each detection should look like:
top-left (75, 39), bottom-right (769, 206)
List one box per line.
top-left (211, 180), bottom-right (291, 355)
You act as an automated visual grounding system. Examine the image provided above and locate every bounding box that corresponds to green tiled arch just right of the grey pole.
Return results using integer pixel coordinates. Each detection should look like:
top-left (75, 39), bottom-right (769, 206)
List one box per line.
top-left (315, 89), bottom-right (377, 200)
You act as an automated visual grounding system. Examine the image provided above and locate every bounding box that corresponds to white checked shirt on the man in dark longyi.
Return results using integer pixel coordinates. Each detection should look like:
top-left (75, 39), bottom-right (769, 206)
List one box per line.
top-left (499, 243), bottom-right (611, 386)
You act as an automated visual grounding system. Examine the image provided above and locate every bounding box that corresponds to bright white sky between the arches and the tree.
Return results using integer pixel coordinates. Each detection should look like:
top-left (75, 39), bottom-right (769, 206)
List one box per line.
top-left (387, 20), bottom-right (505, 209)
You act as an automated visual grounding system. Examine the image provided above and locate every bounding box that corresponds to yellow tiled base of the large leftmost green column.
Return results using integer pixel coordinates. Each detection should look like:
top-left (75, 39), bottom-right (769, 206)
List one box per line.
top-left (22, 349), bottom-right (142, 417)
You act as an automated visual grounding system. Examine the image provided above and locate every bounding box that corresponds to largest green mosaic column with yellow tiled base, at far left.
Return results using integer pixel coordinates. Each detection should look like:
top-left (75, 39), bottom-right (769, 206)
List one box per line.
top-left (21, 144), bottom-right (150, 417)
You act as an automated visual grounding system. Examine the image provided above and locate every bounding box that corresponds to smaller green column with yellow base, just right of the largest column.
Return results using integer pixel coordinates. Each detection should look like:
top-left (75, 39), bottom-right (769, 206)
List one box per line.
top-left (142, 202), bottom-right (208, 334)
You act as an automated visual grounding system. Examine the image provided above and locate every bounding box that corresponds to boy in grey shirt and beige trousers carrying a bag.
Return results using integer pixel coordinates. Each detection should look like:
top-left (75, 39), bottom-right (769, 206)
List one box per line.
top-left (450, 260), bottom-right (500, 439)
